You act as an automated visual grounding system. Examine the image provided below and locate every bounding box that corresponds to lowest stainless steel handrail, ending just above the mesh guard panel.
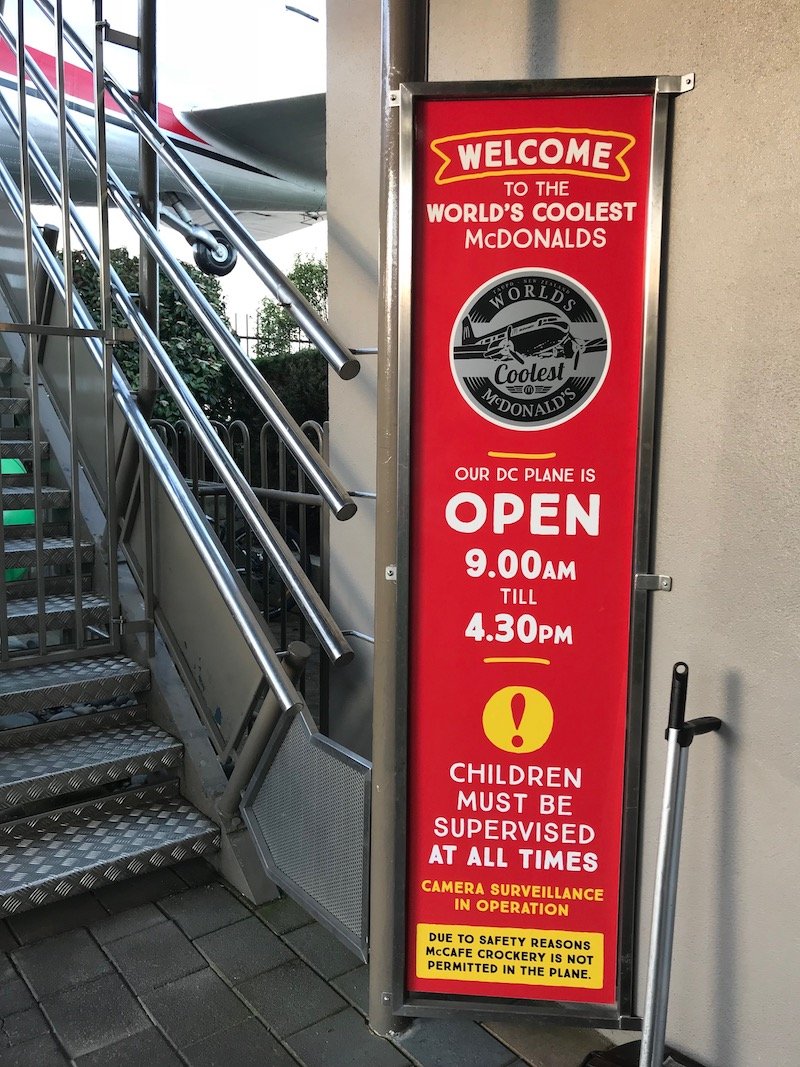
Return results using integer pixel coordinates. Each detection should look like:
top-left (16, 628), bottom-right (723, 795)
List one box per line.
top-left (0, 150), bottom-right (302, 711)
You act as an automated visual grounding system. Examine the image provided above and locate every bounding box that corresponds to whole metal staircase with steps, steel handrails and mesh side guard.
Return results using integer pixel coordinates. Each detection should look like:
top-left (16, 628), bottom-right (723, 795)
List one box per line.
top-left (0, 0), bottom-right (370, 959)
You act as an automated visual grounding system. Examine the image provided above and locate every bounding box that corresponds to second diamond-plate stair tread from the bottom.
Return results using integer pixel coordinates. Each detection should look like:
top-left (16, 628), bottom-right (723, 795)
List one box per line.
top-left (0, 723), bottom-right (182, 806)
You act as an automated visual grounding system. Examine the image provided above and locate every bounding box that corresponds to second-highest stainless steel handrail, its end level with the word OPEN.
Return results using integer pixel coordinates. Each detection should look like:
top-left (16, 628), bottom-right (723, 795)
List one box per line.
top-left (0, 17), bottom-right (356, 520)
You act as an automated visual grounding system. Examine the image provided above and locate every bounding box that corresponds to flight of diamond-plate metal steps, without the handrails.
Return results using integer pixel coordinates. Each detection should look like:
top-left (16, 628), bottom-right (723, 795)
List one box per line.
top-left (0, 359), bottom-right (220, 914)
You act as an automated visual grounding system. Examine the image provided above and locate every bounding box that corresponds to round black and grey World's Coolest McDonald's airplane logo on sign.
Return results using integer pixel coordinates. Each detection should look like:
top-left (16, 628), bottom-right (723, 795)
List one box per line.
top-left (450, 267), bottom-right (611, 430)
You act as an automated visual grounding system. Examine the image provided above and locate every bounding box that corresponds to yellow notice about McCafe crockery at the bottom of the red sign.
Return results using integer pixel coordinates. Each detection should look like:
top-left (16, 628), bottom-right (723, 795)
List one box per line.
top-left (417, 923), bottom-right (603, 989)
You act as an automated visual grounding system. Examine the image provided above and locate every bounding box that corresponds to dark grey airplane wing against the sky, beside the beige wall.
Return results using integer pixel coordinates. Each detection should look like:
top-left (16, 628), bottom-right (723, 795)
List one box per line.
top-left (179, 93), bottom-right (325, 210)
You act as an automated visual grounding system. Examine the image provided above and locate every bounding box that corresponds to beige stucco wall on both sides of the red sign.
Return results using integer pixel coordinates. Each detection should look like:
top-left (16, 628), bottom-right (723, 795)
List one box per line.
top-left (329, 0), bottom-right (800, 1067)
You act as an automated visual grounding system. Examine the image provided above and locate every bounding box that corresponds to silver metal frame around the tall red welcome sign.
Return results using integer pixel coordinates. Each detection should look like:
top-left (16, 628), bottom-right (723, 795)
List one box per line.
top-left (392, 75), bottom-right (693, 1029)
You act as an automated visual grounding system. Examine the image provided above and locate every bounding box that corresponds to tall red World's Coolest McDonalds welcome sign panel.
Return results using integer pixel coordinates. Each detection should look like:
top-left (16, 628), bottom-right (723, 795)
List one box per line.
top-left (405, 95), bottom-right (654, 1005)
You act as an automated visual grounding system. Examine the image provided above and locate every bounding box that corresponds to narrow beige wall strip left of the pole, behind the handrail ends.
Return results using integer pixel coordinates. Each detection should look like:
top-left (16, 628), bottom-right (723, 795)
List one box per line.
top-left (327, 0), bottom-right (381, 757)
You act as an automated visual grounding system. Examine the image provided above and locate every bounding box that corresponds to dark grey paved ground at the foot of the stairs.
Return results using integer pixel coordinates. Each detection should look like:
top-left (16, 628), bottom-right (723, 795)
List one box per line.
top-left (0, 861), bottom-right (603, 1067)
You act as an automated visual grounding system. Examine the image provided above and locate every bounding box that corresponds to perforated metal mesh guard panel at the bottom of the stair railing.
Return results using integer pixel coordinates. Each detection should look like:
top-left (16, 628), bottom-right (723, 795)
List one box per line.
top-left (242, 712), bottom-right (370, 960)
